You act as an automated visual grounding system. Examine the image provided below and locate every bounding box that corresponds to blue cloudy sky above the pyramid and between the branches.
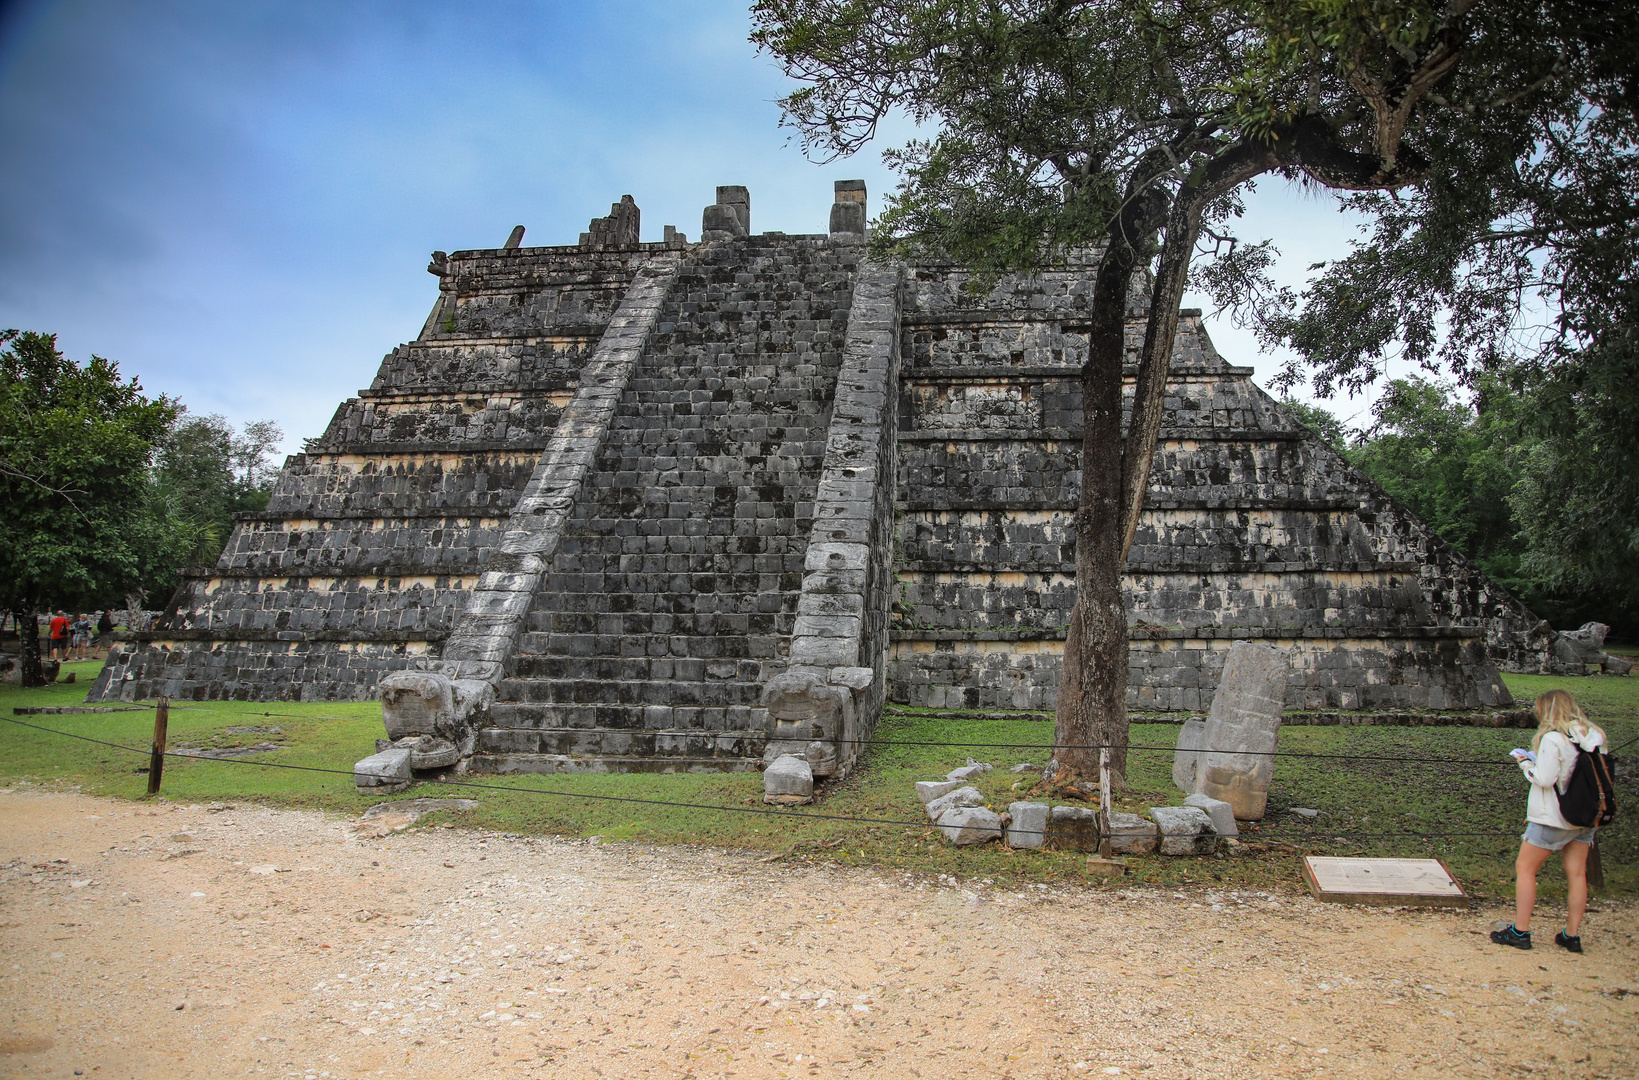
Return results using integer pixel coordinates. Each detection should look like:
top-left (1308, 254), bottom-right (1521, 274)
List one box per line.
top-left (0, 0), bottom-right (1360, 451)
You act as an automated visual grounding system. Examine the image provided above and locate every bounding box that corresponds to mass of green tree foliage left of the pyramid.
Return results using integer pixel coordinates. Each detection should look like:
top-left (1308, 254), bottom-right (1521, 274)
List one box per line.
top-left (0, 331), bottom-right (284, 610)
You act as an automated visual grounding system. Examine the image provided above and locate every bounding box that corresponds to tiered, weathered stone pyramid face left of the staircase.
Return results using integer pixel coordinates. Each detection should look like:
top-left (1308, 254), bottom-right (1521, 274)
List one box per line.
top-left (93, 244), bottom-right (662, 700)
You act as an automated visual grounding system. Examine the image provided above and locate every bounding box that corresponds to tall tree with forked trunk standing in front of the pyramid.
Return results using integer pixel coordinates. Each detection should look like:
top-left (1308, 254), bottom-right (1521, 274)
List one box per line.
top-left (752, 0), bottom-right (1507, 783)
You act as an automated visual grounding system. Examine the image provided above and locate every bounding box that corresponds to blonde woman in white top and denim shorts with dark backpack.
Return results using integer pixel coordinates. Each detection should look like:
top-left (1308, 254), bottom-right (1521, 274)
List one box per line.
top-left (1491, 690), bottom-right (1608, 952)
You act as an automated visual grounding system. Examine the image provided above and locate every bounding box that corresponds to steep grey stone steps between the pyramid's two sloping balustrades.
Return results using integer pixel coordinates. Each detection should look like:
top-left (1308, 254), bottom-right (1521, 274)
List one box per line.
top-left (470, 236), bottom-right (859, 772)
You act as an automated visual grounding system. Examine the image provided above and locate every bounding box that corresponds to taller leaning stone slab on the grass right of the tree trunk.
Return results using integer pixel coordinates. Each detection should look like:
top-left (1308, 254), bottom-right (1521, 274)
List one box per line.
top-left (1195, 641), bottom-right (1287, 821)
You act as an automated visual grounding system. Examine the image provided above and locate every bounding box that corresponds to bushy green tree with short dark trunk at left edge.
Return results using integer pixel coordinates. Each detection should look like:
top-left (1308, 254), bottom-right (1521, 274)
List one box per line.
top-left (0, 329), bottom-right (175, 687)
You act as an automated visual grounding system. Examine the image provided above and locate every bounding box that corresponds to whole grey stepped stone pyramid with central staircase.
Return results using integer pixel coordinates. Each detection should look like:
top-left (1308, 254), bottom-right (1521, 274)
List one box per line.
top-left (92, 182), bottom-right (1555, 775)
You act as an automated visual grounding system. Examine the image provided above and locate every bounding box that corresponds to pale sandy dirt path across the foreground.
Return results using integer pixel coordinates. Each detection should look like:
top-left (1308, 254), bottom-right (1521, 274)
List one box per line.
top-left (0, 790), bottom-right (1639, 1080)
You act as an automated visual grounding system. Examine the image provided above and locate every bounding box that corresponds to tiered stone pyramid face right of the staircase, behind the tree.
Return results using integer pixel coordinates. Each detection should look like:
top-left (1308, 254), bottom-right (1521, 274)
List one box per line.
top-left (893, 267), bottom-right (1542, 711)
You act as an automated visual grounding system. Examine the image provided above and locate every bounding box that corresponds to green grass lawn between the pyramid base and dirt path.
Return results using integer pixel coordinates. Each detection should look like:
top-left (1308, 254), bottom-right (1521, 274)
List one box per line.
top-left (0, 662), bottom-right (1639, 898)
